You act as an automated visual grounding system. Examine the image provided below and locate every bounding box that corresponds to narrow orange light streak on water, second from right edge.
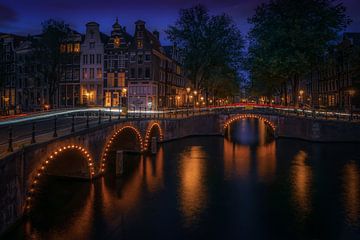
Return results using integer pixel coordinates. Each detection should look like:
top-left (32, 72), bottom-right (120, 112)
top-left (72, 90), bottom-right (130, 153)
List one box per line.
top-left (290, 150), bottom-right (312, 216)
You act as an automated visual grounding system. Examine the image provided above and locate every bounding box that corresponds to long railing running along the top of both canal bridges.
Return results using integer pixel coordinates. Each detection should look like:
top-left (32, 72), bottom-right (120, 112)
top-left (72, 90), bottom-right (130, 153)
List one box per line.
top-left (0, 106), bottom-right (360, 157)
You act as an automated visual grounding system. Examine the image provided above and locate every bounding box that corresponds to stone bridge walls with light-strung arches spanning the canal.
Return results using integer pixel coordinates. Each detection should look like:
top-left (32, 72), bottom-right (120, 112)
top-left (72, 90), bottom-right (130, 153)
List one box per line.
top-left (0, 111), bottom-right (360, 233)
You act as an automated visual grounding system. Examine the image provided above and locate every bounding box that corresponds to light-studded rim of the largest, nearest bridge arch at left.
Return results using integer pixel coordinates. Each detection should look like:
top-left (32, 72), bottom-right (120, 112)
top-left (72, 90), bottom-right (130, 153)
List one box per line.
top-left (24, 144), bottom-right (95, 211)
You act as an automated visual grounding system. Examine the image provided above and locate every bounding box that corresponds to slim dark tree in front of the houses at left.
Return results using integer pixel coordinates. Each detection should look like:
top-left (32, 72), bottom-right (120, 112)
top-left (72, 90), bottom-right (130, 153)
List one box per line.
top-left (34, 19), bottom-right (71, 105)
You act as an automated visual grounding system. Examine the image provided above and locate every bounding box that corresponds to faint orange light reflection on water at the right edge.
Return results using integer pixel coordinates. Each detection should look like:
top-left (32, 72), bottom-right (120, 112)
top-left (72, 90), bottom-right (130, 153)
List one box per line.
top-left (343, 161), bottom-right (360, 225)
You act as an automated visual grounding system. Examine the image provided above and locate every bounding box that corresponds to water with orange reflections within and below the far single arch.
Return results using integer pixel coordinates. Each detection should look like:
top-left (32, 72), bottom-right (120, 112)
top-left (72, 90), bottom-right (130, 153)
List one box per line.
top-left (223, 119), bottom-right (276, 182)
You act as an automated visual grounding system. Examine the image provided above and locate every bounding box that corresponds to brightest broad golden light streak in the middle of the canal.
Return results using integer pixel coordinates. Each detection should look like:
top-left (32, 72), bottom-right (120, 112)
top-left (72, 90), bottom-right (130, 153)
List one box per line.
top-left (179, 146), bottom-right (206, 226)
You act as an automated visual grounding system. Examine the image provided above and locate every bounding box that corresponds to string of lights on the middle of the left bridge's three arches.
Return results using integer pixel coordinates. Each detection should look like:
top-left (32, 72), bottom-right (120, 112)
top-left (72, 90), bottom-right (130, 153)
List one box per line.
top-left (99, 125), bottom-right (144, 173)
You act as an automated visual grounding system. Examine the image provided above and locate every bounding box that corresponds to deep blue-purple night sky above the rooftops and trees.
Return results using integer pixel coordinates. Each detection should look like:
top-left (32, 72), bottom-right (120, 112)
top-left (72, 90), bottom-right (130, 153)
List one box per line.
top-left (0, 0), bottom-right (360, 43)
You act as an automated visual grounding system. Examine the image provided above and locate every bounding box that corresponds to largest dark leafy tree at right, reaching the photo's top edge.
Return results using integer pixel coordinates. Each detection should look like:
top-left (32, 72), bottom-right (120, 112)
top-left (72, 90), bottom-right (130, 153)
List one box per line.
top-left (248, 0), bottom-right (350, 104)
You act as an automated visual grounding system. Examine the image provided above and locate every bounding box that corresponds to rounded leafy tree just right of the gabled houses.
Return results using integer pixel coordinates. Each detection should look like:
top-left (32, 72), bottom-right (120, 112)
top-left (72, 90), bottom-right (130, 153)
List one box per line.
top-left (166, 5), bottom-right (244, 100)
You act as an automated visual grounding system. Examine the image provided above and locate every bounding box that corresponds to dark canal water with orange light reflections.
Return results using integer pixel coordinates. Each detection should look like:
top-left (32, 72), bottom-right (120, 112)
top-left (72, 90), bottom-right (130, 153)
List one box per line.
top-left (5, 119), bottom-right (360, 240)
